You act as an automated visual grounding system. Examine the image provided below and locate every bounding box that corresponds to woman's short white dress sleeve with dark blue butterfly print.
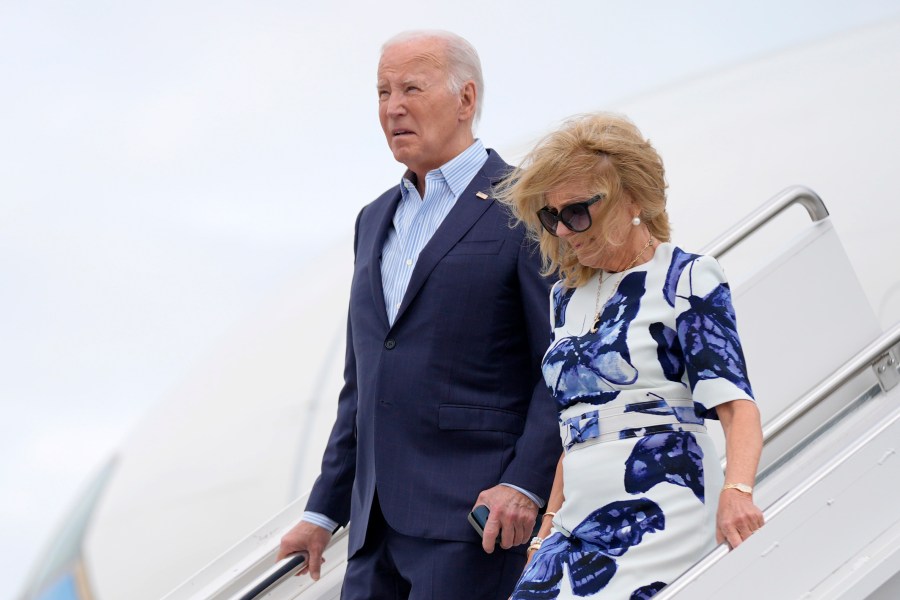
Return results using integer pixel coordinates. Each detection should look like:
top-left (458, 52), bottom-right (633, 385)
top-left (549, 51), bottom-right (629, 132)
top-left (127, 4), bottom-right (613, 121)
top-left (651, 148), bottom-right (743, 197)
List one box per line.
top-left (675, 256), bottom-right (753, 418)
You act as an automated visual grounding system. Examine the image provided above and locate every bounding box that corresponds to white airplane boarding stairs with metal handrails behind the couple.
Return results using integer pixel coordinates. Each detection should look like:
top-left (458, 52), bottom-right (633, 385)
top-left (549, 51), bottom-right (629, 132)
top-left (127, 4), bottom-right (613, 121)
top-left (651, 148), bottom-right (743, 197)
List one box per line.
top-left (164, 186), bottom-right (900, 600)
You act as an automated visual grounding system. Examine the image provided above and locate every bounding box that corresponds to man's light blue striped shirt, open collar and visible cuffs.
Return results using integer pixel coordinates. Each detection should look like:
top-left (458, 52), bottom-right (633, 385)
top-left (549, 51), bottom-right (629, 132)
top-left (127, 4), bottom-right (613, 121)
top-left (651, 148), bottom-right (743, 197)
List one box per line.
top-left (301, 139), bottom-right (544, 531)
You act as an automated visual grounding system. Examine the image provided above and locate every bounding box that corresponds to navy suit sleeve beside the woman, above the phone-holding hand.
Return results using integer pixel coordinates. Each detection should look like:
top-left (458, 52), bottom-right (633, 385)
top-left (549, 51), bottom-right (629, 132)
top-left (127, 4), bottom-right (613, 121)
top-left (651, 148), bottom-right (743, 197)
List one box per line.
top-left (501, 234), bottom-right (562, 501)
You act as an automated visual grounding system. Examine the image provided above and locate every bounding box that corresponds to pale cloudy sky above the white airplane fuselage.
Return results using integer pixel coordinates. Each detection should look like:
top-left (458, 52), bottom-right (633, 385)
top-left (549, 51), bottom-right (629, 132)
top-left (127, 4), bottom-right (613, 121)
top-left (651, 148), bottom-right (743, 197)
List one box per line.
top-left (0, 0), bottom-right (900, 598)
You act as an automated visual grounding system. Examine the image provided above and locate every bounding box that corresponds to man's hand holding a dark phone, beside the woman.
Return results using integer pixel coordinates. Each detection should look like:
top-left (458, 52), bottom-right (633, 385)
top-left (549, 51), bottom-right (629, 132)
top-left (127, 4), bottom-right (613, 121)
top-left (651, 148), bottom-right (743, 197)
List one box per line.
top-left (475, 485), bottom-right (538, 554)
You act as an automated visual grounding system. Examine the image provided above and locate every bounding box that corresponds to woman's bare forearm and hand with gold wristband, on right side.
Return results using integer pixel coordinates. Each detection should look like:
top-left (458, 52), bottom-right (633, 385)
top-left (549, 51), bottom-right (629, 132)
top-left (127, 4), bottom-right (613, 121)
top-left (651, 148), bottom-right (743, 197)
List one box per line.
top-left (716, 400), bottom-right (763, 548)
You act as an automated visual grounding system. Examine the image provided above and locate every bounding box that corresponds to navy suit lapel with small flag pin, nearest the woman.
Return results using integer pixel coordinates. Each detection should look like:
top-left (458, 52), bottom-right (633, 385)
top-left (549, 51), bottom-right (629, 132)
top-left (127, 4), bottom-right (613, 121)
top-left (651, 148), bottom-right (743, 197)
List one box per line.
top-left (396, 150), bottom-right (509, 324)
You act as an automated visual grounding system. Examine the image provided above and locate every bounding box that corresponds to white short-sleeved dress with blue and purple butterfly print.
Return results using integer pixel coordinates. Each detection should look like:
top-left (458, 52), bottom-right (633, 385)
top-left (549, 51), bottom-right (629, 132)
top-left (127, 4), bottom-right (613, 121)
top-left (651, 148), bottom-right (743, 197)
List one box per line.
top-left (512, 243), bottom-right (753, 600)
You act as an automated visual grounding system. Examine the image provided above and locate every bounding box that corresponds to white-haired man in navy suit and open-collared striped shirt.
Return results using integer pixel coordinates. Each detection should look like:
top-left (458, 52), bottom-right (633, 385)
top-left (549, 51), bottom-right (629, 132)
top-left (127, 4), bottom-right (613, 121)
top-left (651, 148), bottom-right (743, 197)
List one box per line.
top-left (279, 32), bottom-right (561, 600)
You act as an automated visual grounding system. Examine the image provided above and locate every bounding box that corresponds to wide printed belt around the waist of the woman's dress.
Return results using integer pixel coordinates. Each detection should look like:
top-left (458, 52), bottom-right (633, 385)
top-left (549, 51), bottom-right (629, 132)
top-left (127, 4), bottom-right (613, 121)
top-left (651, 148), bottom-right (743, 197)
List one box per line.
top-left (560, 399), bottom-right (706, 452)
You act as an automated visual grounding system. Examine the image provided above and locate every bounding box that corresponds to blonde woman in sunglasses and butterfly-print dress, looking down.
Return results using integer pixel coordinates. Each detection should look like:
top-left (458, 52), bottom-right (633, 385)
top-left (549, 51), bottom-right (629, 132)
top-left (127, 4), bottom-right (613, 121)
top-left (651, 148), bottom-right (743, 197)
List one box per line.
top-left (500, 114), bottom-right (763, 600)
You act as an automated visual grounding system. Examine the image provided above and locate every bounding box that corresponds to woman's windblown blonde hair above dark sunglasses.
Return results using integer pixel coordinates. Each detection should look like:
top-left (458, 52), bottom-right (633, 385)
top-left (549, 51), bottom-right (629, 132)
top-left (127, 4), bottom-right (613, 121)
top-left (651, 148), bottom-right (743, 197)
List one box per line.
top-left (495, 113), bottom-right (670, 287)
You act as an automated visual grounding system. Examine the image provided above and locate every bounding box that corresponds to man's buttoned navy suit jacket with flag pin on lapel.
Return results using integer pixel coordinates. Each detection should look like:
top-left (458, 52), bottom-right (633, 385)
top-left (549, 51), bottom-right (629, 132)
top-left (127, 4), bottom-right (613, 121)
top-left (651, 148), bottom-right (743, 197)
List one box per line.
top-left (306, 151), bottom-right (562, 556)
